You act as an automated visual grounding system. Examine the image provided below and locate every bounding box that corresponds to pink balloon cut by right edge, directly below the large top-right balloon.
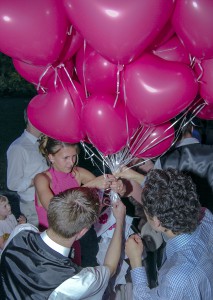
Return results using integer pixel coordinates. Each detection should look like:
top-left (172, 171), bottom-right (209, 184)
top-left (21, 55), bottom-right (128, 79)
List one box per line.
top-left (195, 59), bottom-right (213, 104)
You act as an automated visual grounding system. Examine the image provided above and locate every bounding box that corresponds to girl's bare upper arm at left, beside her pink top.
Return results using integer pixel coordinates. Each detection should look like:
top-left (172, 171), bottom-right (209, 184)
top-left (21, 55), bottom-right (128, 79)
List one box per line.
top-left (34, 173), bottom-right (54, 210)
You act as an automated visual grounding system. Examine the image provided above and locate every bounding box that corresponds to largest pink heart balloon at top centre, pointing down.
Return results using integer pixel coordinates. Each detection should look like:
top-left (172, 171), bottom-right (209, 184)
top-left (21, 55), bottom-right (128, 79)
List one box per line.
top-left (63, 0), bottom-right (174, 64)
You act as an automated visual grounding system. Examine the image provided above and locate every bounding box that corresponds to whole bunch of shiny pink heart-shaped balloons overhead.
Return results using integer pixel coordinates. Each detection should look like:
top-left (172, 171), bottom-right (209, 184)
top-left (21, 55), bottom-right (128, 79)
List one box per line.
top-left (0, 0), bottom-right (213, 157)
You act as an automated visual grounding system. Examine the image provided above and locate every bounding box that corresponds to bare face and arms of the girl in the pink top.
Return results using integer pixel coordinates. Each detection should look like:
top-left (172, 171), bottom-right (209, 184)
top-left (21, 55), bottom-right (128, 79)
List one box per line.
top-left (34, 145), bottom-right (125, 210)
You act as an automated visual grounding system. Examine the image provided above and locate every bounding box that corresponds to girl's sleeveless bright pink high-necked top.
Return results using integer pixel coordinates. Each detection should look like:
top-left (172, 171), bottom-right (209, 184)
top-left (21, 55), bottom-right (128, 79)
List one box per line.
top-left (35, 168), bottom-right (79, 229)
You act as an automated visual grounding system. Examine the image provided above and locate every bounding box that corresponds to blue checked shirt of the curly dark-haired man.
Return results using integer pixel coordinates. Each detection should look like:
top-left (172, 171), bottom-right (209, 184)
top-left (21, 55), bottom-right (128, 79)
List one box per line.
top-left (131, 209), bottom-right (213, 300)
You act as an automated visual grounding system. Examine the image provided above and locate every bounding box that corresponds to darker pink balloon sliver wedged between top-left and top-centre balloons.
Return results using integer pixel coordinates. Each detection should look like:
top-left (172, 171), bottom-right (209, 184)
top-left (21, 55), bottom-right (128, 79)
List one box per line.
top-left (59, 26), bottom-right (84, 62)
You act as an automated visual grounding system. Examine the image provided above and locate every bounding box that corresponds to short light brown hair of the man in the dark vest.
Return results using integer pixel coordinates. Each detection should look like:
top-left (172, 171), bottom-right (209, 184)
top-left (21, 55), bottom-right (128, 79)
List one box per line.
top-left (47, 187), bottom-right (100, 238)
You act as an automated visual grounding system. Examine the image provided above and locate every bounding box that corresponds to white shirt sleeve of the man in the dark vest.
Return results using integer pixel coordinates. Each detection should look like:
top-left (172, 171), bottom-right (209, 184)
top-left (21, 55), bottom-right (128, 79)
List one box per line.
top-left (48, 266), bottom-right (110, 300)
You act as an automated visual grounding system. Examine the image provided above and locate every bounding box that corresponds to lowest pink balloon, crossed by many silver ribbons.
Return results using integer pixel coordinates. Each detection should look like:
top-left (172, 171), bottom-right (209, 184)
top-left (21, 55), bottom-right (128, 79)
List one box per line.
top-left (130, 122), bottom-right (175, 158)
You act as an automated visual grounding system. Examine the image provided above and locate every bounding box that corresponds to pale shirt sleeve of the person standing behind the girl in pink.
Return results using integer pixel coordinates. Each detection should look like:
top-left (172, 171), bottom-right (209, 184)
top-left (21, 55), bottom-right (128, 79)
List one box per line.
top-left (7, 145), bottom-right (32, 192)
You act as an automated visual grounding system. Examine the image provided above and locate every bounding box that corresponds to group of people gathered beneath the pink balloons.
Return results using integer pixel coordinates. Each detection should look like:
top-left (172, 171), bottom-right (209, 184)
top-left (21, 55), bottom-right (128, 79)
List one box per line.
top-left (0, 109), bottom-right (213, 300)
